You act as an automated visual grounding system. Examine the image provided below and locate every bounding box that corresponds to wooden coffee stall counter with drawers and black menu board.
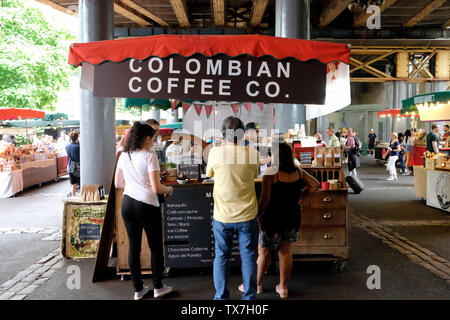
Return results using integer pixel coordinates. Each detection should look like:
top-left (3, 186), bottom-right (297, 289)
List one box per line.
top-left (115, 168), bottom-right (350, 274)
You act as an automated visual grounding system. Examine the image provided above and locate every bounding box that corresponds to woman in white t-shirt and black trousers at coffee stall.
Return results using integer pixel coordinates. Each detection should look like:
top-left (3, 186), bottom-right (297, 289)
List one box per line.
top-left (115, 122), bottom-right (173, 300)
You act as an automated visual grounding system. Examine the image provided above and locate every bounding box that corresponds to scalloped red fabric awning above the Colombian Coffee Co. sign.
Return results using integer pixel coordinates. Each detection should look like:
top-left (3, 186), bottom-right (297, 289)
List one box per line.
top-left (68, 35), bottom-right (350, 67)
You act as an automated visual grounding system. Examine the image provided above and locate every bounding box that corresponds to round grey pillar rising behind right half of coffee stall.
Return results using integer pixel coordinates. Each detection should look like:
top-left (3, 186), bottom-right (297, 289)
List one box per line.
top-left (275, 0), bottom-right (310, 133)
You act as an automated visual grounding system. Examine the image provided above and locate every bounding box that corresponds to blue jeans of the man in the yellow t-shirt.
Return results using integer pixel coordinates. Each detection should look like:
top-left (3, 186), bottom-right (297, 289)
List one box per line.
top-left (213, 219), bottom-right (259, 300)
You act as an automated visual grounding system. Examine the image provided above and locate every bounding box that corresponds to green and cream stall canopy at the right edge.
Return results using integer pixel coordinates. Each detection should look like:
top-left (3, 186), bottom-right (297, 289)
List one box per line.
top-left (401, 91), bottom-right (450, 121)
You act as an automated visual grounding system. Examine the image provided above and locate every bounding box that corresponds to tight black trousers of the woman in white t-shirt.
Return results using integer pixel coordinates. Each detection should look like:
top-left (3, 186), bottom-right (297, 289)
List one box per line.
top-left (122, 195), bottom-right (164, 292)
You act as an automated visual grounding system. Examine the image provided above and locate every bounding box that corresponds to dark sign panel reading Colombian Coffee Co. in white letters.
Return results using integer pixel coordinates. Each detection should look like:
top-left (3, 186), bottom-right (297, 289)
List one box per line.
top-left (81, 54), bottom-right (327, 104)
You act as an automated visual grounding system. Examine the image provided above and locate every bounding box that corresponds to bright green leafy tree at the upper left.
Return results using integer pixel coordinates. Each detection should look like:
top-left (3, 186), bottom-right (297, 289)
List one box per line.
top-left (0, 0), bottom-right (75, 110)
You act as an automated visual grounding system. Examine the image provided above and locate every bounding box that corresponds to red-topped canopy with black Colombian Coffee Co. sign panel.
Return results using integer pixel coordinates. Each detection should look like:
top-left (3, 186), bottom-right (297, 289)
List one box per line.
top-left (69, 35), bottom-right (350, 105)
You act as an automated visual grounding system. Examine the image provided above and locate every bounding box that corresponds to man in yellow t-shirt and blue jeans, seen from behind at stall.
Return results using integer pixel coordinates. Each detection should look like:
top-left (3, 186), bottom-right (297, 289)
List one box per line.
top-left (206, 117), bottom-right (259, 300)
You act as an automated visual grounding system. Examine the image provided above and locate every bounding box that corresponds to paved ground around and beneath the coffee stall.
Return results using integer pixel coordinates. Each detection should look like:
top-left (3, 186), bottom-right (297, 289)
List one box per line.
top-left (0, 158), bottom-right (450, 300)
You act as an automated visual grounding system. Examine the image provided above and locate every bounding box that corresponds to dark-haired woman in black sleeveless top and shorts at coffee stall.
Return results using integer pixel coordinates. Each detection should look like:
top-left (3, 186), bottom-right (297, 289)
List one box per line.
top-left (250, 142), bottom-right (320, 299)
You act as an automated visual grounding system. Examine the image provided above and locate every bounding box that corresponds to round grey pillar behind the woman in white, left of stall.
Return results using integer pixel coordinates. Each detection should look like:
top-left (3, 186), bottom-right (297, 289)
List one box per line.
top-left (78, 0), bottom-right (116, 193)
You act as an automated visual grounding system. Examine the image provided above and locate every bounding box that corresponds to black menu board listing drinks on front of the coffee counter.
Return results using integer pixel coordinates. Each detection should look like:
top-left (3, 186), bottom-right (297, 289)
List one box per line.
top-left (164, 185), bottom-right (240, 268)
